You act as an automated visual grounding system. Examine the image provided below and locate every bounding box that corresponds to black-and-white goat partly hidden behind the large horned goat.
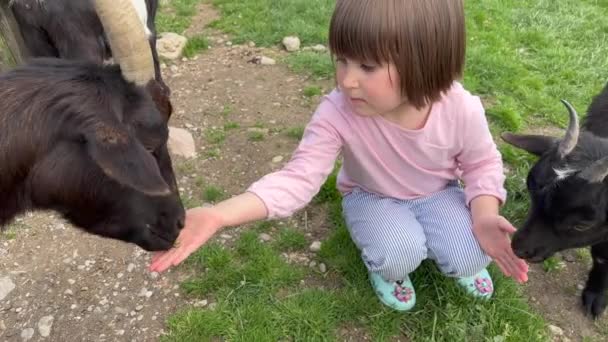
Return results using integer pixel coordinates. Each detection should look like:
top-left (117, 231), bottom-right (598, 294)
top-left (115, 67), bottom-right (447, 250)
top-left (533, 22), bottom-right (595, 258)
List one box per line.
top-left (10, 0), bottom-right (170, 98)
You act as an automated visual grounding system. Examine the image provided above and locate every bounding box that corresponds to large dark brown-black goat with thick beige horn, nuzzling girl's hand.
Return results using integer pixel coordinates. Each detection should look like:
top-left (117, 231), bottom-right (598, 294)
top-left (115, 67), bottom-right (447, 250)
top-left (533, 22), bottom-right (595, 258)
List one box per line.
top-left (0, 0), bottom-right (184, 250)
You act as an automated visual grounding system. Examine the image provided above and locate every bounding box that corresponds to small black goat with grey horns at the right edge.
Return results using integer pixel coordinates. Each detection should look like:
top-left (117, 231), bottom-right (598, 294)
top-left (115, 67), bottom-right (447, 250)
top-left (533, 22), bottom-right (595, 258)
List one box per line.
top-left (502, 84), bottom-right (608, 318)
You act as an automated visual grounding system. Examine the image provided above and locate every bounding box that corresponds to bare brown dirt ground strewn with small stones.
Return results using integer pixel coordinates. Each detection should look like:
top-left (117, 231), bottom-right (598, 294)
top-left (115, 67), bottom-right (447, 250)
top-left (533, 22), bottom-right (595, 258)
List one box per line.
top-left (0, 5), bottom-right (606, 341)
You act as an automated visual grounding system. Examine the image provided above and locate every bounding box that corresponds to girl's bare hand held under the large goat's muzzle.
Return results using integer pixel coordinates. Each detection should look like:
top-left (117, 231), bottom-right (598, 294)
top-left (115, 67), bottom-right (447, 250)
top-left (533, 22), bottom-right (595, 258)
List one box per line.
top-left (149, 207), bottom-right (222, 272)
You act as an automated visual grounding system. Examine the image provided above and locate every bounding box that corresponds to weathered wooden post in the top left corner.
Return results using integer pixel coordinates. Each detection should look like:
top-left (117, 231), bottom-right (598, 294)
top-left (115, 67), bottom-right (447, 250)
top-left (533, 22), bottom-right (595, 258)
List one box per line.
top-left (0, 0), bottom-right (28, 71)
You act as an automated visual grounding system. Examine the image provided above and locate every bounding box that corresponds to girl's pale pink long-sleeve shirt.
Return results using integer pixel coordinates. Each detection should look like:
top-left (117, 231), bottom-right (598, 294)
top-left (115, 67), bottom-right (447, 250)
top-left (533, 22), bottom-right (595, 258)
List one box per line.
top-left (247, 82), bottom-right (506, 218)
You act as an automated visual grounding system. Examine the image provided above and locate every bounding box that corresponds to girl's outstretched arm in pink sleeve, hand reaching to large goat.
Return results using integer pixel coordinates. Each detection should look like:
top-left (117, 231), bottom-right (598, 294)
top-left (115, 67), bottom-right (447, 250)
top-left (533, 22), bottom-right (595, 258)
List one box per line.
top-left (150, 97), bottom-right (342, 272)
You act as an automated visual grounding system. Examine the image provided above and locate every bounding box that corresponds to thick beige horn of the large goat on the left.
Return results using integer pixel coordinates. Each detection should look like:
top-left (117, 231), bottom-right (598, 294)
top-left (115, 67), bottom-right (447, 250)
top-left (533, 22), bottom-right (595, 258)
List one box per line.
top-left (94, 0), bottom-right (154, 85)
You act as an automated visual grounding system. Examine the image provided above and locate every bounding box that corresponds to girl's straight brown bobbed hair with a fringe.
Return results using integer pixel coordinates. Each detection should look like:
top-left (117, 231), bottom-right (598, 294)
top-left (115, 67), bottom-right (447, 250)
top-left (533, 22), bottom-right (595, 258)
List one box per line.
top-left (329, 0), bottom-right (466, 108)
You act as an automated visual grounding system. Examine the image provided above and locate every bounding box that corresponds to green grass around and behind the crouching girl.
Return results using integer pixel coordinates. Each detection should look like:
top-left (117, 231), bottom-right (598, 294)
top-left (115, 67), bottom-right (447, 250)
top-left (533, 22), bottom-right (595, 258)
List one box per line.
top-left (160, 0), bottom-right (608, 342)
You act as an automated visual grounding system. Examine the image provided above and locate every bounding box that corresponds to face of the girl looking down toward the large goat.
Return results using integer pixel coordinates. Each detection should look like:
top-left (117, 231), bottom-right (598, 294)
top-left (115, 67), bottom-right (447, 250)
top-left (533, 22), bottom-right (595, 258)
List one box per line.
top-left (336, 57), bottom-right (404, 116)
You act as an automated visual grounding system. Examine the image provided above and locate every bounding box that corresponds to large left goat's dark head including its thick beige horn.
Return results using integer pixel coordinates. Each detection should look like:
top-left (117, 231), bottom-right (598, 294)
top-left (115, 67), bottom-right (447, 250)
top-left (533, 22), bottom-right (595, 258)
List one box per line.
top-left (49, 0), bottom-right (184, 250)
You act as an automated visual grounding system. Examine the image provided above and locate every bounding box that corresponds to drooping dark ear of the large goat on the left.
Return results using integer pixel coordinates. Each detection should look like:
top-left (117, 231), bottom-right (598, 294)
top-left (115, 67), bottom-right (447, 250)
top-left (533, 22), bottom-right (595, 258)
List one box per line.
top-left (85, 123), bottom-right (170, 196)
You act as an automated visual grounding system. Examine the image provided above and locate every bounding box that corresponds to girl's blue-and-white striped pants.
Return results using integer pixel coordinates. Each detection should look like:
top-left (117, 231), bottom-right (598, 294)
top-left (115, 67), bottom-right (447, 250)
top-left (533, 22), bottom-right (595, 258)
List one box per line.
top-left (342, 183), bottom-right (491, 281)
